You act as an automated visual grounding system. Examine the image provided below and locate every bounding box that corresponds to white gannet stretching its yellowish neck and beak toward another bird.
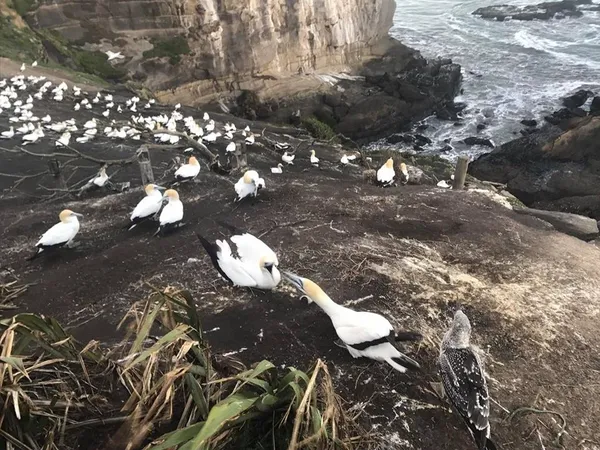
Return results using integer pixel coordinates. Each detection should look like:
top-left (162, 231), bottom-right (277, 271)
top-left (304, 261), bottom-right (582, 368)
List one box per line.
top-left (282, 272), bottom-right (421, 372)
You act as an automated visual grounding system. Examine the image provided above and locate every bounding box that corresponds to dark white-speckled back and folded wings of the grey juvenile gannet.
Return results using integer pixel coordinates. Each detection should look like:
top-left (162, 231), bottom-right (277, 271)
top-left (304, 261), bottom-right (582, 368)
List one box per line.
top-left (439, 348), bottom-right (490, 440)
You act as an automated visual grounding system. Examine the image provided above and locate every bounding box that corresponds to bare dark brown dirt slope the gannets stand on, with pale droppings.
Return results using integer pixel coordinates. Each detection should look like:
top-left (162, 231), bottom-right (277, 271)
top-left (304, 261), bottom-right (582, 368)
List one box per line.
top-left (0, 72), bottom-right (600, 450)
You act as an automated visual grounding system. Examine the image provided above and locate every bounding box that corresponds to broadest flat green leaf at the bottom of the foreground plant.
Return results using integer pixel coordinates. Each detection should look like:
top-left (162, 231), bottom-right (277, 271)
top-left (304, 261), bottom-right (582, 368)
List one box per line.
top-left (188, 394), bottom-right (257, 450)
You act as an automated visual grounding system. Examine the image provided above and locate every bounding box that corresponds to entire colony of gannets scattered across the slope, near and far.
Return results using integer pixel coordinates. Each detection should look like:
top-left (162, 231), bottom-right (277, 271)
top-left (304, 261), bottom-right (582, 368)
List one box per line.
top-left (0, 68), bottom-right (496, 450)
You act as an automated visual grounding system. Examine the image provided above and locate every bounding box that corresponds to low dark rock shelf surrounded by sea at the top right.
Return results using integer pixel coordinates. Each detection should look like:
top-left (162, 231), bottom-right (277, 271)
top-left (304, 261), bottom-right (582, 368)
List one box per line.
top-left (473, 0), bottom-right (592, 21)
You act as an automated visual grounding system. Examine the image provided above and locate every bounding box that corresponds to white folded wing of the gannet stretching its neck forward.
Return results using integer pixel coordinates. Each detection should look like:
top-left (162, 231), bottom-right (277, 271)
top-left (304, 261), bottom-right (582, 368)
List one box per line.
top-left (332, 310), bottom-right (394, 348)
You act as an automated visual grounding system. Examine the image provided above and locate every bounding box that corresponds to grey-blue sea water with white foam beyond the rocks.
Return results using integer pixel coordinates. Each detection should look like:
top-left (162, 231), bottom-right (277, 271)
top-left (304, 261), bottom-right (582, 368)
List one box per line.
top-left (390, 0), bottom-right (600, 159)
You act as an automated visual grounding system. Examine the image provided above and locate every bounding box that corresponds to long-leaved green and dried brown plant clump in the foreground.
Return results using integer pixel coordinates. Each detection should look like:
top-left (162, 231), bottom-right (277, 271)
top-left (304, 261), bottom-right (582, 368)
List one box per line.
top-left (0, 288), bottom-right (364, 450)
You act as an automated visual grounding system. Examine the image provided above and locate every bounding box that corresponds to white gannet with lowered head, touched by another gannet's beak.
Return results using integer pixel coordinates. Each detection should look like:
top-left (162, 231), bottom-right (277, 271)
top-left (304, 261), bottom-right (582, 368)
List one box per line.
top-left (197, 224), bottom-right (281, 289)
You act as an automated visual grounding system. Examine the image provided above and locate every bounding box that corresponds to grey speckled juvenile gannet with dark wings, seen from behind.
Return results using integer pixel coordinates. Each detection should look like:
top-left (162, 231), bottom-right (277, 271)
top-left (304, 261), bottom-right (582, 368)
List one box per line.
top-left (438, 310), bottom-right (496, 450)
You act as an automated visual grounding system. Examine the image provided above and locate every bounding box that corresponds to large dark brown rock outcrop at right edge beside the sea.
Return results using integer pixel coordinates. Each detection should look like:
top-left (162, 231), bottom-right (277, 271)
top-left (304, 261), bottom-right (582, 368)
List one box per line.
top-left (469, 116), bottom-right (600, 219)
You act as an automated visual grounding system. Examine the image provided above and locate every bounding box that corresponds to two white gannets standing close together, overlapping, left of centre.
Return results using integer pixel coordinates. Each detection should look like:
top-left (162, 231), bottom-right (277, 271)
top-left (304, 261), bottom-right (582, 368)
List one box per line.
top-left (127, 184), bottom-right (183, 236)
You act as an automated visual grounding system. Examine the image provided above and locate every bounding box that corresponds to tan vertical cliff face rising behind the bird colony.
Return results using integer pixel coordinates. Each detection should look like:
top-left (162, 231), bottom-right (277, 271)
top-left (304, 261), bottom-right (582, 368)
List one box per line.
top-left (29, 0), bottom-right (396, 96)
